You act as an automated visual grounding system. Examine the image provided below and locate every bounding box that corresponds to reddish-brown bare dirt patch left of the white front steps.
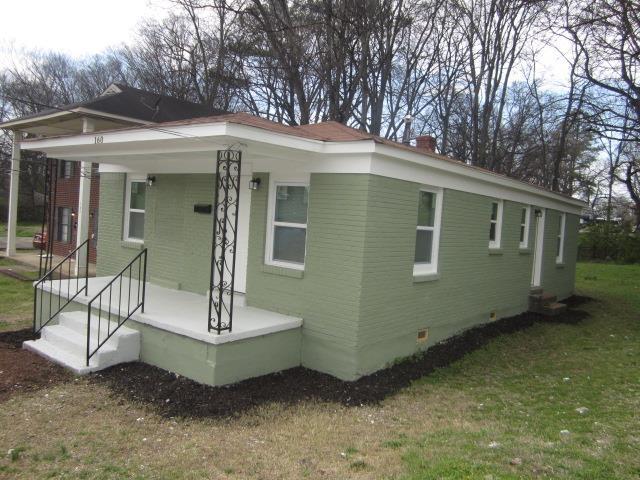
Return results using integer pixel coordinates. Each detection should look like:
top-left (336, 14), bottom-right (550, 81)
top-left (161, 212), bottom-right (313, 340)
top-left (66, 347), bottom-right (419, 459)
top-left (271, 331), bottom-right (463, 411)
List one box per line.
top-left (0, 329), bottom-right (71, 402)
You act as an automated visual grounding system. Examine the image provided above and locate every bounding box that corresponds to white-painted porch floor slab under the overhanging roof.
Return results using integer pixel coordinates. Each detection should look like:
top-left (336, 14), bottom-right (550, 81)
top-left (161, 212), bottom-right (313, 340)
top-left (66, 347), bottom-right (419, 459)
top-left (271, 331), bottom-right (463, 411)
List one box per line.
top-left (37, 277), bottom-right (302, 345)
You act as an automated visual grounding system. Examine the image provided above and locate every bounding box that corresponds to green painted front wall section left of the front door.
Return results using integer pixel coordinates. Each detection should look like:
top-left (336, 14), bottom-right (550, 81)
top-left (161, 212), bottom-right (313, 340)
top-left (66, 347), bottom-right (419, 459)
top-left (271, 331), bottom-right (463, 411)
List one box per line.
top-left (97, 173), bottom-right (214, 295)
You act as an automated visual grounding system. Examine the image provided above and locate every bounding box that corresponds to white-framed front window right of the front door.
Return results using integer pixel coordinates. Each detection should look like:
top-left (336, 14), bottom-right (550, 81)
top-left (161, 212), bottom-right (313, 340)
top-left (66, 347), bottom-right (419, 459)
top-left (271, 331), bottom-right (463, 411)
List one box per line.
top-left (265, 182), bottom-right (309, 270)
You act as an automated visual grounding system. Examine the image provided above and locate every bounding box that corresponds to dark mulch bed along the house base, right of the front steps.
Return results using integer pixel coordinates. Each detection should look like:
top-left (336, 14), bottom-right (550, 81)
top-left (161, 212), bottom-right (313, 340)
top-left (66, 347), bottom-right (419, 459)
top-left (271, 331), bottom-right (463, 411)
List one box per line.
top-left (93, 297), bottom-right (588, 417)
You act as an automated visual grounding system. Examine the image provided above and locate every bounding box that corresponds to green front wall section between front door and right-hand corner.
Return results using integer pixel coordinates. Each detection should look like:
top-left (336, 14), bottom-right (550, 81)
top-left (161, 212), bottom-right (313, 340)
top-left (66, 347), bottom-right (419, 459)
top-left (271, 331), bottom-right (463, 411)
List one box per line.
top-left (247, 173), bottom-right (368, 378)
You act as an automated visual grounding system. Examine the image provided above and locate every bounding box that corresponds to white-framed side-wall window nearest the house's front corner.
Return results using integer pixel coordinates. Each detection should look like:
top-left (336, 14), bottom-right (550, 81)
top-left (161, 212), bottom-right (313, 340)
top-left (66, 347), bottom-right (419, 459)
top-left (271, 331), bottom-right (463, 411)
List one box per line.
top-left (413, 189), bottom-right (442, 275)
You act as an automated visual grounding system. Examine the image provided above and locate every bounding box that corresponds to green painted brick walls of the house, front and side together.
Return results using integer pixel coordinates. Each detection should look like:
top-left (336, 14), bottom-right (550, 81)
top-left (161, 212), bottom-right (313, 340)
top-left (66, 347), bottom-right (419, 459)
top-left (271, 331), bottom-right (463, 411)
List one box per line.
top-left (98, 173), bottom-right (578, 380)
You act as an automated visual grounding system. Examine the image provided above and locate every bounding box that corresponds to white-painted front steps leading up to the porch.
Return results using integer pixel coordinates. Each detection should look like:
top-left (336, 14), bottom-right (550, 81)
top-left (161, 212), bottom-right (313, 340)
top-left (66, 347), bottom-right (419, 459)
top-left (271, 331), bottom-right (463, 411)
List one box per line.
top-left (22, 311), bottom-right (140, 375)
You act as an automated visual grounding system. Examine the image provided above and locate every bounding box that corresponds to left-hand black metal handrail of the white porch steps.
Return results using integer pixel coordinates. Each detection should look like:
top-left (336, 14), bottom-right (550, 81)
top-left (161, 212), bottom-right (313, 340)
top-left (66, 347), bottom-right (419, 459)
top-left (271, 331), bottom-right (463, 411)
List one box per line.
top-left (33, 239), bottom-right (91, 335)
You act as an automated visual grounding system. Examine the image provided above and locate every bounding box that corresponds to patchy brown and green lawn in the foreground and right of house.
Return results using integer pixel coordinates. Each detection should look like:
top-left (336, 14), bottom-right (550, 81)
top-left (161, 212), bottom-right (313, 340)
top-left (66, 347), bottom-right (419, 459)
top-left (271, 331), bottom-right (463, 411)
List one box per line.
top-left (0, 264), bottom-right (640, 480)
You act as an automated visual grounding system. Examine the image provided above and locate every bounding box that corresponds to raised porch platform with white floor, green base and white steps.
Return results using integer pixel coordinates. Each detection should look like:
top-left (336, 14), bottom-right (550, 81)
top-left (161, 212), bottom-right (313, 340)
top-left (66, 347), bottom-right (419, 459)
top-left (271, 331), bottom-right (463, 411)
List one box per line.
top-left (33, 276), bottom-right (302, 385)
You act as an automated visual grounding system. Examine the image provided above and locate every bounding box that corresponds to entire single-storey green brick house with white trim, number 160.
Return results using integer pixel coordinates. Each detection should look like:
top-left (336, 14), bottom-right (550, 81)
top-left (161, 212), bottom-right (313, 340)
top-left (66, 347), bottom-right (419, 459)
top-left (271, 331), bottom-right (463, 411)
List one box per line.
top-left (15, 113), bottom-right (584, 385)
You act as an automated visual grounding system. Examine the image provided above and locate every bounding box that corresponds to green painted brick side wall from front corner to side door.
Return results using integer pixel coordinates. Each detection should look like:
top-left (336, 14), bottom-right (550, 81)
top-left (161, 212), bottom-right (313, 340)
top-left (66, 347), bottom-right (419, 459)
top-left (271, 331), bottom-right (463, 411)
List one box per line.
top-left (357, 176), bottom-right (533, 375)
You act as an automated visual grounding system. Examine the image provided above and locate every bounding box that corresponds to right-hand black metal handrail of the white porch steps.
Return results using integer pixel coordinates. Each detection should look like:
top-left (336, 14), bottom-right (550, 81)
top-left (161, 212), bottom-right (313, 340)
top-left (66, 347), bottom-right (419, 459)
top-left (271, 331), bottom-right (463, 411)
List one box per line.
top-left (86, 248), bottom-right (147, 366)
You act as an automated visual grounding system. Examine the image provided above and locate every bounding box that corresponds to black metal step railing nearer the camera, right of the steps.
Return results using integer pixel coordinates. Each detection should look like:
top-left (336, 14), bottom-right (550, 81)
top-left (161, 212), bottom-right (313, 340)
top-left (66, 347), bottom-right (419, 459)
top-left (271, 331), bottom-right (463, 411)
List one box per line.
top-left (87, 248), bottom-right (147, 366)
